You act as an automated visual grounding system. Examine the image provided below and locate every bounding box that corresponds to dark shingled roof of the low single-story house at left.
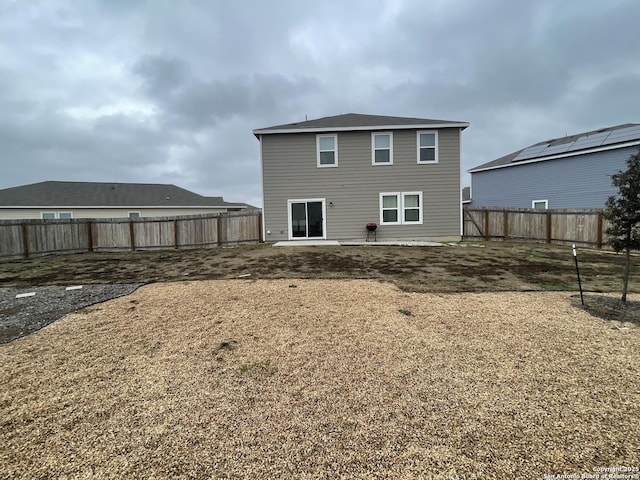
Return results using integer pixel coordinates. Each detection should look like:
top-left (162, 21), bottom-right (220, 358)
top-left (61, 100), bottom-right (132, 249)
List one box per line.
top-left (0, 181), bottom-right (245, 208)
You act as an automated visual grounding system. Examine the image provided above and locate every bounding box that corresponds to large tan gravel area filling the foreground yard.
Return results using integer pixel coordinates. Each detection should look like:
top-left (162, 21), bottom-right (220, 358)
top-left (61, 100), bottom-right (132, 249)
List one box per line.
top-left (0, 280), bottom-right (640, 479)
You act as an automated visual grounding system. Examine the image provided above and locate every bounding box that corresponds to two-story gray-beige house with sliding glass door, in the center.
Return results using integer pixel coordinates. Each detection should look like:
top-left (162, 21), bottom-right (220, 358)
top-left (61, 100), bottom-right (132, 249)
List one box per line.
top-left (253, 113), bottom-right (469, 241)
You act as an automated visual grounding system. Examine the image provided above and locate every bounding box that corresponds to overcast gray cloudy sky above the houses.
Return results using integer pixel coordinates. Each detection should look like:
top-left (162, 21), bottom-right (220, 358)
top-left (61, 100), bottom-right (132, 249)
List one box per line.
top-left (0, 0), bottom-right (640, 205)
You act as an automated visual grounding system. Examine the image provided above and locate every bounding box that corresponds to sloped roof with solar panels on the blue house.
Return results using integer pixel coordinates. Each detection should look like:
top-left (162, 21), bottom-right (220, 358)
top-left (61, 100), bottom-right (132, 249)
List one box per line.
top-left (468, 123), bottom-right (640, 173)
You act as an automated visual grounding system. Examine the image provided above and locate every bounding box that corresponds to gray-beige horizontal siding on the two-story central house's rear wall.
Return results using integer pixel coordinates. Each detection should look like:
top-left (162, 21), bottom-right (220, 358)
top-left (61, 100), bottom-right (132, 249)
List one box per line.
top-left (261, 128), bottom-right (460, 241)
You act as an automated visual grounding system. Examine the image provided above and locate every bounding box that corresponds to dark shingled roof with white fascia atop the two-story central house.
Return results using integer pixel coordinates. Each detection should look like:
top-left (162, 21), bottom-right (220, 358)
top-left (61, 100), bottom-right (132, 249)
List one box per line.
top-left (253, 113), bottom-right (469, 136)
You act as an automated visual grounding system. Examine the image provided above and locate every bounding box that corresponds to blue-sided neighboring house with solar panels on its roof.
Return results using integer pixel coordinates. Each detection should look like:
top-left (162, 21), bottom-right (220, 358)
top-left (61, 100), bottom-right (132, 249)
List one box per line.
top-left (469, 123), bottom-right (640, 209)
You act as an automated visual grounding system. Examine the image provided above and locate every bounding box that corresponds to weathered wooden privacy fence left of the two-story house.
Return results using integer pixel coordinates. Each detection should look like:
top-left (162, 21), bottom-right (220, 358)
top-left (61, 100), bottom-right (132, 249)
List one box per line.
top-left (0, 213), bottom-right (262, 258)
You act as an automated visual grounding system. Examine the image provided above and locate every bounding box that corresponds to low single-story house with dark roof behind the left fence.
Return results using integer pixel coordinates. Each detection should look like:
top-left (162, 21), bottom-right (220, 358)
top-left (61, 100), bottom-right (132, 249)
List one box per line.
top-left (0, 181), bottom-right (253, 220)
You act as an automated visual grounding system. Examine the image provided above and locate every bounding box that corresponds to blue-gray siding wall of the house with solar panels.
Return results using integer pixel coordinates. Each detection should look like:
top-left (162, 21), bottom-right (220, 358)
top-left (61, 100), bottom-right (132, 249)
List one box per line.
top-left (471, 147), bottom-right (637, 208)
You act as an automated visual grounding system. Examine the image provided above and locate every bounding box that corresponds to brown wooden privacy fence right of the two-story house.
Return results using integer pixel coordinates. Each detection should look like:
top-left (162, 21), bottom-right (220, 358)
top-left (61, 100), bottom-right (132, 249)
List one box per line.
top-left (463, 207), bottom-right (609, 248)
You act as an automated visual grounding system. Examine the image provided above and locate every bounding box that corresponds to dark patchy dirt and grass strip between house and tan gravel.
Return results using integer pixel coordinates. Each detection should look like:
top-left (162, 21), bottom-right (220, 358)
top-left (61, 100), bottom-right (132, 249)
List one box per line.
top-left (0, 242), bottom-right (640, 292)
